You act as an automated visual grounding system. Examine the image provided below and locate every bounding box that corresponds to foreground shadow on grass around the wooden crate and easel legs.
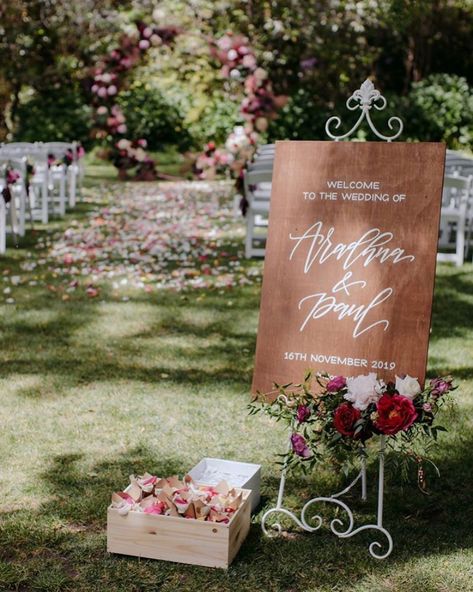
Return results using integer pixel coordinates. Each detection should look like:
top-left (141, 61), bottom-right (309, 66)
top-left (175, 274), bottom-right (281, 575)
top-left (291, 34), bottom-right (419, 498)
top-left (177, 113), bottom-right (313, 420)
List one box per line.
top-left (0, 440), bottom-right (473, 592)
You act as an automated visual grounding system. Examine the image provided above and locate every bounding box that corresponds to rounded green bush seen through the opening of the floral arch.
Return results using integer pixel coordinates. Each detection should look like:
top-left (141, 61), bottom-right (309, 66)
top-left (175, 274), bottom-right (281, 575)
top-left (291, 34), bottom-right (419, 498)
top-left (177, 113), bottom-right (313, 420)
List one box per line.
top-left (117, 80), bottom-right (192, 150)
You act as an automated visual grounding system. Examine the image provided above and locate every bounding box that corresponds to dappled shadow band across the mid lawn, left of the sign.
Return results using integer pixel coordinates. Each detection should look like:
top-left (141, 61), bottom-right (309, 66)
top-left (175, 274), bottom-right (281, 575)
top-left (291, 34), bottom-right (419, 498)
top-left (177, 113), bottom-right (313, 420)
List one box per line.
top-left (0, 289), bottom-right (256, 394)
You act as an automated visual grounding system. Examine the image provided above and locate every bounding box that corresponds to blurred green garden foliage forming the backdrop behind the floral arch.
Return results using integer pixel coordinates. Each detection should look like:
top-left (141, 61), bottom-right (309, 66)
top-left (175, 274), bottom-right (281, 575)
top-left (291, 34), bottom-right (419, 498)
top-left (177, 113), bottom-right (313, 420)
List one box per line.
top-left (0, 0), bottom-right (473, 150)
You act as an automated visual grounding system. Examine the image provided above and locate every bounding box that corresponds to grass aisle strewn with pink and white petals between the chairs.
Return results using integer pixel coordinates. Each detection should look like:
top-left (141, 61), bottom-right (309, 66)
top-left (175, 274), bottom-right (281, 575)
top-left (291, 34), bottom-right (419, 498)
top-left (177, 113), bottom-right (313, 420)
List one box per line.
top-left (4, 182), bottom-right (261, 304)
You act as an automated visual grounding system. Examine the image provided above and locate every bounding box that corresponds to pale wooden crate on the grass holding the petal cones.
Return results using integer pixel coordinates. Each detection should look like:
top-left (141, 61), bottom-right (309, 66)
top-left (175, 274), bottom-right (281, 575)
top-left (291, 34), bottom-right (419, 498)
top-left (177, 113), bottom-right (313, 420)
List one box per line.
top-left (107, 489), bottom-right (251, 568)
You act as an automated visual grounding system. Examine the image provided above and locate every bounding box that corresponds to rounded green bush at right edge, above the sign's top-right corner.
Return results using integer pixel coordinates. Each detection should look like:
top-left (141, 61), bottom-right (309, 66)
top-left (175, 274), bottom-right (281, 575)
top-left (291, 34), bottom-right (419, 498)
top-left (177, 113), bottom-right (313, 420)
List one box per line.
top-left (401, 74), bottom-right (473, 148)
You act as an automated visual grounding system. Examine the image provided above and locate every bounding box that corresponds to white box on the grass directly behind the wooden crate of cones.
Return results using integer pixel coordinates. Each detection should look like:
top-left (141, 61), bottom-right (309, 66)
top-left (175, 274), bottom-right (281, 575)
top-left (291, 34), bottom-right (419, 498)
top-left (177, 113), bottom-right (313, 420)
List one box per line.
top-left (189, 458), bottom-right (261, 512)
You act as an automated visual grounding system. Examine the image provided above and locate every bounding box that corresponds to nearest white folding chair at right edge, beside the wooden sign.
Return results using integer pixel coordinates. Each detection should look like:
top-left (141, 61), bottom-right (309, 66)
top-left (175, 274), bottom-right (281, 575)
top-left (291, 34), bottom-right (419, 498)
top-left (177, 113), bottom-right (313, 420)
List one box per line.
top-left (437, 175), bottom-right (473, 266)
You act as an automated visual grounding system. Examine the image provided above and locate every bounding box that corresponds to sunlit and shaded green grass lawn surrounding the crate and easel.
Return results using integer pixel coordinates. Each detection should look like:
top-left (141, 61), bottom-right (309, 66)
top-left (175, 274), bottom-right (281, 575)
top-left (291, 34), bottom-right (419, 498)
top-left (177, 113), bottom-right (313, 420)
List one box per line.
top-left (0, 177), bottom-right (473, 592)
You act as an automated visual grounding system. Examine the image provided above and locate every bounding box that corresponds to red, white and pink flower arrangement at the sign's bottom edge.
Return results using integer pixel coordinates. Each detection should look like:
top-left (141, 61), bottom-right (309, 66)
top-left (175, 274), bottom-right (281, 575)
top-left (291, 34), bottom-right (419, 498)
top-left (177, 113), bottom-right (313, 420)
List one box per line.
top-left (249, 372), bottom-right (457, 480)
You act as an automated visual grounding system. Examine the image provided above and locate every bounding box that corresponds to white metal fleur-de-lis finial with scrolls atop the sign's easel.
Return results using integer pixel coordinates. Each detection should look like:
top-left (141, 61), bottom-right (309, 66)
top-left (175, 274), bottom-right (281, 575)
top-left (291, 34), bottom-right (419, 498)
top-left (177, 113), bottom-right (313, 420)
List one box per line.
top-left (325, 79), bottom-right (404, 142)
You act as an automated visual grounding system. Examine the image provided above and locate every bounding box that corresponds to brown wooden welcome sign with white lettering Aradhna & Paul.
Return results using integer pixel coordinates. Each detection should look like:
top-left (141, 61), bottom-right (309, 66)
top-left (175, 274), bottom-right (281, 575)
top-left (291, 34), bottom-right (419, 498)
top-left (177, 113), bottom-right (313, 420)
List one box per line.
top-left (252, 142), bottom-right (445, 393)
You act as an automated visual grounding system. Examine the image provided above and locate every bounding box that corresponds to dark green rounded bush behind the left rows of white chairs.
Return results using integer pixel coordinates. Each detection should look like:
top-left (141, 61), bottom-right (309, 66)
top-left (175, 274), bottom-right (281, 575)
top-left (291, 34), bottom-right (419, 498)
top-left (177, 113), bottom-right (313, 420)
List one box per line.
top-left (14, 83), bottom-right (91, 148)
